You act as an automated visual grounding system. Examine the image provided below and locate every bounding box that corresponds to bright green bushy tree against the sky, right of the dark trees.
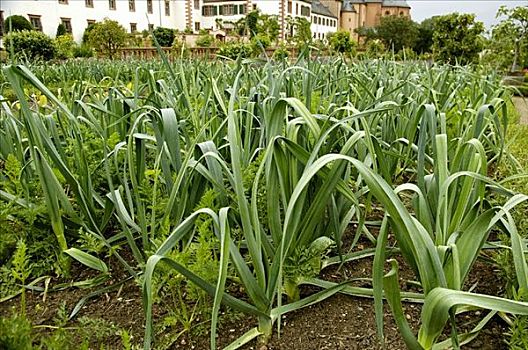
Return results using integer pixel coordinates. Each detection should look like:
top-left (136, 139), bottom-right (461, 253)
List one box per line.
top-left (433, 13), bottom-right (484, 64)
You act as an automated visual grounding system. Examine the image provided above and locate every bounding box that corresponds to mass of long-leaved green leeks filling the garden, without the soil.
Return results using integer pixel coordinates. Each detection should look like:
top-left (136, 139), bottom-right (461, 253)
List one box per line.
top-left (0, 59), bottom-right (528, 349)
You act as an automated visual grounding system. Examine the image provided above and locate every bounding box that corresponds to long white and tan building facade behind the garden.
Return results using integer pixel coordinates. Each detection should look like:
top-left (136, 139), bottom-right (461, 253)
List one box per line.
top-left (0, 0), bottom-right (410, 41)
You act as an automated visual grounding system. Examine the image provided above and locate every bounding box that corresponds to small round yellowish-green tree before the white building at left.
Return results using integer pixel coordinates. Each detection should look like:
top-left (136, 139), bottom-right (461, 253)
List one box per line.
top-left (88, 18), bottom-right (127, 58)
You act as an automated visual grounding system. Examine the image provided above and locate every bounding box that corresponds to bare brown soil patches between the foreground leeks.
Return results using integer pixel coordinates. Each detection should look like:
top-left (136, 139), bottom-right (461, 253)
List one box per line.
top-left (0, 237), bottom-right (507, 350)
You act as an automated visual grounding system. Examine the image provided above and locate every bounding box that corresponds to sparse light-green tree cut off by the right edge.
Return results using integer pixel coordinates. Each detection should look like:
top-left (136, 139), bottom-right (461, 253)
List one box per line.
top-left (495, 6), bottom-right (528, 72)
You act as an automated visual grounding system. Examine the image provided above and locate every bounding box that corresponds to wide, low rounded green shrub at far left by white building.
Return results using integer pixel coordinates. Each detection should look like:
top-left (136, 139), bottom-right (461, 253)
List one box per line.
top-left (5, 30), bottom-right (56, 60)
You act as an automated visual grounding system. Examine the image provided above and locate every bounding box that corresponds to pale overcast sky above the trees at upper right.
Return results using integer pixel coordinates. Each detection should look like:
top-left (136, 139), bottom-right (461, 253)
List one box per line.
top-left (407, 0), bottom-right (528, 28)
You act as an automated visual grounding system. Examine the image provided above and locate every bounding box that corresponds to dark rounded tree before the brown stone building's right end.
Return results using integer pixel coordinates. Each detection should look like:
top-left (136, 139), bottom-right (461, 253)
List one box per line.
top-left (376, 16), bottom-right (418, 52)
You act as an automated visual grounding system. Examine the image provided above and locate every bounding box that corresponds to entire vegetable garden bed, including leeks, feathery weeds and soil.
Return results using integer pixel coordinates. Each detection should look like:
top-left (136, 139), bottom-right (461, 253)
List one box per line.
top-left (0, 57), bottom-right (528, 349)
